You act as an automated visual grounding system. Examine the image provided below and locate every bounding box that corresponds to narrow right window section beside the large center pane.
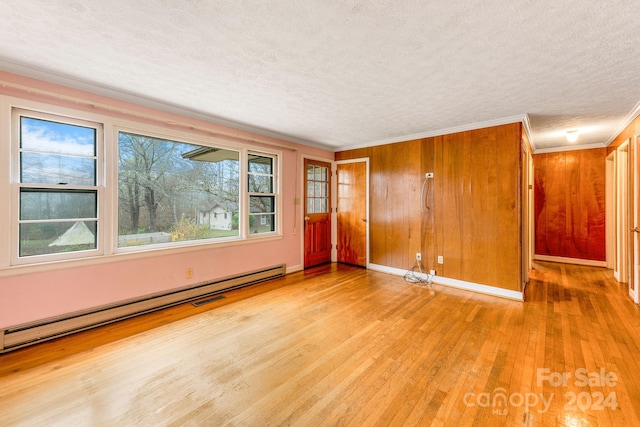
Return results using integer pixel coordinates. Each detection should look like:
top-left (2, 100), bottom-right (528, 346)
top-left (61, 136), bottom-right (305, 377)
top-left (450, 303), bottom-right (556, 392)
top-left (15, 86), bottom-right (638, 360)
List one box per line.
top-left (247, 153), bottom-right (276, 235)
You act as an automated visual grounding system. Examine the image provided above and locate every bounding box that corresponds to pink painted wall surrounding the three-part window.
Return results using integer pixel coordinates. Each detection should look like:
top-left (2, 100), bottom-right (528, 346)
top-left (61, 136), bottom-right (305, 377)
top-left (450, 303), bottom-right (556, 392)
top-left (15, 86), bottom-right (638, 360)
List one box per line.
top-left (0, 72), bottom-right (333, 329)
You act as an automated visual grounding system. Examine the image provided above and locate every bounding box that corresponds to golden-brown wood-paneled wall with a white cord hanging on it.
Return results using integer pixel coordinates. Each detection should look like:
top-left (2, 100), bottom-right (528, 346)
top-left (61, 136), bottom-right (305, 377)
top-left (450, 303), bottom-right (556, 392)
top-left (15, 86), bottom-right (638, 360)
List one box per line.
top-left (336, 123), bottom-right (522, 290)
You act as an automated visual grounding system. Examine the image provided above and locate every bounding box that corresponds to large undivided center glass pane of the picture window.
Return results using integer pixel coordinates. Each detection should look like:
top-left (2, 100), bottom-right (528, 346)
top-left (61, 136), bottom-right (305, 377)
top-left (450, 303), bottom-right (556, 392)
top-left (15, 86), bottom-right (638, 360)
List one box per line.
top-left (118, 132), bottom-right (240, 248)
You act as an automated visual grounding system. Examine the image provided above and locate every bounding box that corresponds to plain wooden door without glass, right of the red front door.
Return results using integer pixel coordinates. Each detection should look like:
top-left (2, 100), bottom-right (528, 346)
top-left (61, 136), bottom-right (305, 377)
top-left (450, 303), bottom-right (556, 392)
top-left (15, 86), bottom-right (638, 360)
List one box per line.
top-left (336, 161), bottom-right (368, 267)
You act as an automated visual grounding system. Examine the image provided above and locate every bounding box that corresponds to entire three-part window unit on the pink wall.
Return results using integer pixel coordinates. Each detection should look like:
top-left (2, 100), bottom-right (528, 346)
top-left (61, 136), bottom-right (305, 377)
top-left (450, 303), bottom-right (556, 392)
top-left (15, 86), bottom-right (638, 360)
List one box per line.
top-left (5, 104), bottom-right (281, 265)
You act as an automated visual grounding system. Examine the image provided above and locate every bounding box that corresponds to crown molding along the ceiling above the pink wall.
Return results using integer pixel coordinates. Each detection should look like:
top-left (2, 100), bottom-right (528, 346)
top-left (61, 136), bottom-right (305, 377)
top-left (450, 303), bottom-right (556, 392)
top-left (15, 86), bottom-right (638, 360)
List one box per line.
top-left (0, 58), bottom-right (335, 152)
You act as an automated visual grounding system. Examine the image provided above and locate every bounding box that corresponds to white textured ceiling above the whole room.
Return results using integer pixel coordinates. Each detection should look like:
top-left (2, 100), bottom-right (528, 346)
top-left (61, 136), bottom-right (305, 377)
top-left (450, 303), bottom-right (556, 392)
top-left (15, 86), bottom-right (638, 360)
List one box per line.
top-left (0, 0), bottom-right (640, 150)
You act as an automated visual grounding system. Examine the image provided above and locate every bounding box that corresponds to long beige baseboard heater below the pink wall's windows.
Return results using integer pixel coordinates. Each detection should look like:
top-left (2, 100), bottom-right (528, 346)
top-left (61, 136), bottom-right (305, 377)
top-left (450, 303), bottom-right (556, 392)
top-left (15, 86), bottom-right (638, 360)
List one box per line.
top-left (0, 264), bottom-right (286, 353)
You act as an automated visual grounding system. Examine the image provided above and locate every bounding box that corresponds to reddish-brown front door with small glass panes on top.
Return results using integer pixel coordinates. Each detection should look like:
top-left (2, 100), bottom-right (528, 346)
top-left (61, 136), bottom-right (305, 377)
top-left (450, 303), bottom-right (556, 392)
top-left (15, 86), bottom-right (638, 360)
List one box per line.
top-left (304, 159), bottom-right (331, 268)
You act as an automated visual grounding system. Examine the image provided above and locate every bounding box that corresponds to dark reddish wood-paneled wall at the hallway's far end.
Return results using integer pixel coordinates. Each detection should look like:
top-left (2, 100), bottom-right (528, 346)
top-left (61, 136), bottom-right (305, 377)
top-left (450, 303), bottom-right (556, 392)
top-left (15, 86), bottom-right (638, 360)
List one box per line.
top-left (533, 148), bottom-right (606, 261)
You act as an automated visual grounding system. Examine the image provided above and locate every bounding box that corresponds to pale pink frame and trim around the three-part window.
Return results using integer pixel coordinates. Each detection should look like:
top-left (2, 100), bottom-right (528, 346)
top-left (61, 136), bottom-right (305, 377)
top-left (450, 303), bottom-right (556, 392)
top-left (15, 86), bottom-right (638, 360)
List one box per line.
top-left (0, 99), bottom-right (284, 270)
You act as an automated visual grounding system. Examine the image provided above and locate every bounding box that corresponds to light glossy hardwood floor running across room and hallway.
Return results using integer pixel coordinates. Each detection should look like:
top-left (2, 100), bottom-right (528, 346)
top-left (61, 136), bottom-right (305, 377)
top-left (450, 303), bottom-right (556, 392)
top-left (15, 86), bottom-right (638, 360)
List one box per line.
top-left (0, 263), bottom-right (640, 426)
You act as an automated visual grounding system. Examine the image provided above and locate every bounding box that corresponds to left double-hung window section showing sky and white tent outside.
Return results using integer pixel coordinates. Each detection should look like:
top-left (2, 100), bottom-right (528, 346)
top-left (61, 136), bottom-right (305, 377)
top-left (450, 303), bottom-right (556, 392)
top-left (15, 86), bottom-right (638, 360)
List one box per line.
top-left (14, 110), bottom-right (101, 260)
